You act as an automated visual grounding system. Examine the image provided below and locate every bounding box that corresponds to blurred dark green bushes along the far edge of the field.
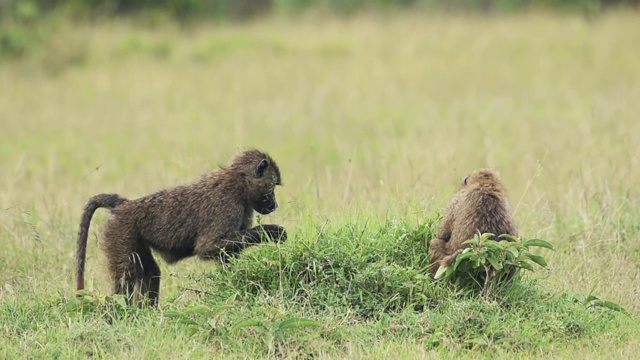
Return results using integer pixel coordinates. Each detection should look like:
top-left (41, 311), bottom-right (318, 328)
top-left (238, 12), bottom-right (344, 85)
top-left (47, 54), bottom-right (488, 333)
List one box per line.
top-left (0, 0), bottom-right (640, 58)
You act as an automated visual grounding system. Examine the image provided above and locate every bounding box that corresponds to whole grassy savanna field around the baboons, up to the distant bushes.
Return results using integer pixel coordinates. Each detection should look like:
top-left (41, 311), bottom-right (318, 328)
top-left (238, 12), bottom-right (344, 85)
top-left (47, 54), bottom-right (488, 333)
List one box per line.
top-left (0, 11), bottom-right (640, 359)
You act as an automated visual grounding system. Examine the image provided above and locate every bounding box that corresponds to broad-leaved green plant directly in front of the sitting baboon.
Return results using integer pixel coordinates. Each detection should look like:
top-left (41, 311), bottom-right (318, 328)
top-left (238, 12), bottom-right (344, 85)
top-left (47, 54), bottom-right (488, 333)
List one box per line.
top-left (435, 233), bottom-right (554, 296)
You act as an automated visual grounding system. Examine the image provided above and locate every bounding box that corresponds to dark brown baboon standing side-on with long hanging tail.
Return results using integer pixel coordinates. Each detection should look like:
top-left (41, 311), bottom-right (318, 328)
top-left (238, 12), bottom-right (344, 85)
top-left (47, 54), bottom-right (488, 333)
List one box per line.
top-left (76, 149), bottom-right (287, 306)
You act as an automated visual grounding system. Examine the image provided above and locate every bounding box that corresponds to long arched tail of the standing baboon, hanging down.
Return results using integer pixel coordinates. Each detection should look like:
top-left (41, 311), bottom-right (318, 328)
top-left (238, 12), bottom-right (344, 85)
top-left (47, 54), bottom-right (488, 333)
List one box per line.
top-left (76, 194), bottom-right (127, 290)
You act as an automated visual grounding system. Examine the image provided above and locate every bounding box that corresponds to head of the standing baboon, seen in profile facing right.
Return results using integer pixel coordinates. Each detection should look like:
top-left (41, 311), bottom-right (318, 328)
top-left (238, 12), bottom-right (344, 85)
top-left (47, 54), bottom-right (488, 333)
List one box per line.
top-left (233, 149), bottom-right (282, 215)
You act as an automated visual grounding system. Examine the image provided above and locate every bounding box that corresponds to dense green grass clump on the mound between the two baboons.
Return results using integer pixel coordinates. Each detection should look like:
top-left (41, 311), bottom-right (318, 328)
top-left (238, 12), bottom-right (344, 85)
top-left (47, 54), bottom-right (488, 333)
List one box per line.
top-left (200, 221), bottom-right (443, 319)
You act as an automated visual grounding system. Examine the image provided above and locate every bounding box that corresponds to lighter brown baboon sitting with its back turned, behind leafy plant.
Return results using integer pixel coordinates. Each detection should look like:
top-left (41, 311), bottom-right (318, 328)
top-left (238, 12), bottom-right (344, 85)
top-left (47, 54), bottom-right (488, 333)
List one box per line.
top-left (429, 169), bottom-right (518, 275)
